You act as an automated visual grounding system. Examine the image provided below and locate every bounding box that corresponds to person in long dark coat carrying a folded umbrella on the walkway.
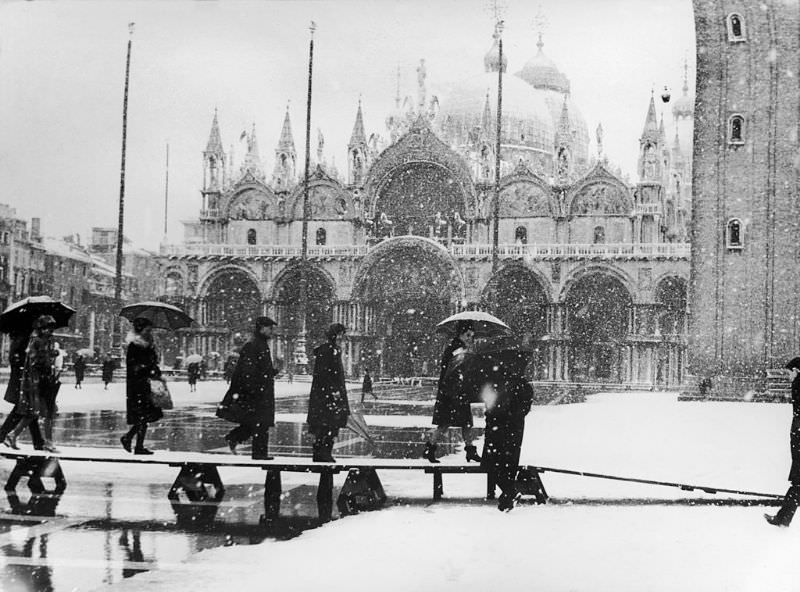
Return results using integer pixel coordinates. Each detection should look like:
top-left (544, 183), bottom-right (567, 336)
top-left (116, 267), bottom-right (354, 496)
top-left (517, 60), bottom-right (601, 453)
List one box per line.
top-left (306, 323), bottom-right (350, 462)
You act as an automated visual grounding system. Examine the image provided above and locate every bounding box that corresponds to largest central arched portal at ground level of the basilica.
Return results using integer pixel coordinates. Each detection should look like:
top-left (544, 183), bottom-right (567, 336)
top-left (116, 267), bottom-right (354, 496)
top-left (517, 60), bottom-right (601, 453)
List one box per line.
top-left (353, 237), bottom-right (462, 376)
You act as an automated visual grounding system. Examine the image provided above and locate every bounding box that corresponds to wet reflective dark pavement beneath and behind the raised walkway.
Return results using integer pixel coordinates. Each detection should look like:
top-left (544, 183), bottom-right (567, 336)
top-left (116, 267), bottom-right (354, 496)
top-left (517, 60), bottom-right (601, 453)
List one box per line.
top-left (0, 398), bottom-right (482, 592)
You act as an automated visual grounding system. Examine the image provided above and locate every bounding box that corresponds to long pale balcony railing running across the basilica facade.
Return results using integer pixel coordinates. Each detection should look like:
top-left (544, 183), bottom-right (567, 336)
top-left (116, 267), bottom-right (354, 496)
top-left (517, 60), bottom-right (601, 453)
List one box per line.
top-left (161, 243), bottom-right (691, 260)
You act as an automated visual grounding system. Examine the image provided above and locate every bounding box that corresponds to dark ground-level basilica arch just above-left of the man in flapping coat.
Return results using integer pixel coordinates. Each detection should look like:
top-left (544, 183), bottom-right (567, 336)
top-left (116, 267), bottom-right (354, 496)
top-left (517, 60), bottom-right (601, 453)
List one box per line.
top-left (201, 266), bottom-right (262, 338)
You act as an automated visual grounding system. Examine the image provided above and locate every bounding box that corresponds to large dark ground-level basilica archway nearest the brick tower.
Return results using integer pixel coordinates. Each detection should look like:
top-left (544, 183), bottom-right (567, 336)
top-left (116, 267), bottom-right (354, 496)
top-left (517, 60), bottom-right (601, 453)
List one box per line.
top-left (566, 272), bottom-right (633, 382)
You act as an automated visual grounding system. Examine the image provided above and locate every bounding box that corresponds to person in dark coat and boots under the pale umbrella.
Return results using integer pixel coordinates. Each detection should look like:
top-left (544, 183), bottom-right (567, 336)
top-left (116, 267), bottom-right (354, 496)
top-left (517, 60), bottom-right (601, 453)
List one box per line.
top-left (422, 321), bottom-right (481, 463)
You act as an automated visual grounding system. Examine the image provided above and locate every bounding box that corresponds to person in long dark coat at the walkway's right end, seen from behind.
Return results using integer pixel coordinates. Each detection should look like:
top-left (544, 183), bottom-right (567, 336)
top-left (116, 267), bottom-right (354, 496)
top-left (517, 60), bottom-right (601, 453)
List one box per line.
top-left (481, 349), bottom-right (533, 511)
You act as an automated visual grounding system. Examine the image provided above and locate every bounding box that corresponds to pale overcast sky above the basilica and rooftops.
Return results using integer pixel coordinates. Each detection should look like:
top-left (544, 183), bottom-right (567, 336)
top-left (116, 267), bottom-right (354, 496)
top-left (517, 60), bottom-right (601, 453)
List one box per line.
top-left (0, 0), bottom-right (695, 248)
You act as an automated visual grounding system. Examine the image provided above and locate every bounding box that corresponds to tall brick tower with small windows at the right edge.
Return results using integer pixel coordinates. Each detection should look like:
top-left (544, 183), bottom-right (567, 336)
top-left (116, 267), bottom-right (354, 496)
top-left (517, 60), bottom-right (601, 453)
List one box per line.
top-left (689, 0), bottom-right (800, 394)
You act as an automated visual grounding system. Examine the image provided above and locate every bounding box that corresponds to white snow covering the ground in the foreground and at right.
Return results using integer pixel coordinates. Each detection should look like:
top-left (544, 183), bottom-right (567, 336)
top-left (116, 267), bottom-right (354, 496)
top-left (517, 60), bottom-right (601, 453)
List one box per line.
top-left (87, 393), bottom-right (800, 592)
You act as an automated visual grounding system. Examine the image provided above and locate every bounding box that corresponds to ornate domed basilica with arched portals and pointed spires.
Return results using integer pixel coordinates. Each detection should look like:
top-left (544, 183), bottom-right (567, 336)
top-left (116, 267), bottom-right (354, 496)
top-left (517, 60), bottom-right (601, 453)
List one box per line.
top-left (160, 36), bottom-right (694, 385)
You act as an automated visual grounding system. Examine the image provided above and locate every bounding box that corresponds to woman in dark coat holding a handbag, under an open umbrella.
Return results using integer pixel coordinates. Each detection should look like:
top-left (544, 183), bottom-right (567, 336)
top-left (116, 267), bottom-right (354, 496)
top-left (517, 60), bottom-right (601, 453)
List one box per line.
top-left (120, 317), bottom-right (164, 454)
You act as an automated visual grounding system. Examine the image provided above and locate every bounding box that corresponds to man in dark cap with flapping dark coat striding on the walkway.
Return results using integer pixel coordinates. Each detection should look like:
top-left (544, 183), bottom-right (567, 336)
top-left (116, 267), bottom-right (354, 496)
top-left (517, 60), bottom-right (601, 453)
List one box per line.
top-left (217, 317), bottom-right (277, 460)
